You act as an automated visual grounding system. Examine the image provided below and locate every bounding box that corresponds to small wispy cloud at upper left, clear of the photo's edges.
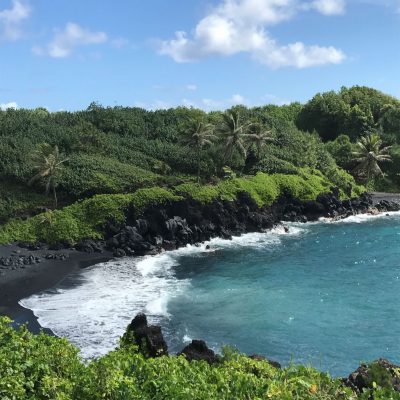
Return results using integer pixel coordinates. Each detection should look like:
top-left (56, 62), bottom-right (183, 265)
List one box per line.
top-left (32, 22), bottom-right (108, 58)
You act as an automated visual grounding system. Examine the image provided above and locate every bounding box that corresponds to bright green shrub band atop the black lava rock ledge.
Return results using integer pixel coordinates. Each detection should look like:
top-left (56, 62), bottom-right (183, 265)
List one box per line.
top-left (0, 169), bottom-right (363, 244)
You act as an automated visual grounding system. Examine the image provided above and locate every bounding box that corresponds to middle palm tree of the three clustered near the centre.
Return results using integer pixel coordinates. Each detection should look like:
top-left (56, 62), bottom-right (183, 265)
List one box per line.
top-left (219, 111), bottom-right (252, 163)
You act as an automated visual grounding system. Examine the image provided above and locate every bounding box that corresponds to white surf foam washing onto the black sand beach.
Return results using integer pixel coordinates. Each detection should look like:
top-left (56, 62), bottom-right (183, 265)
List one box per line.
top-left (20, 224), bottom-right (306, 358)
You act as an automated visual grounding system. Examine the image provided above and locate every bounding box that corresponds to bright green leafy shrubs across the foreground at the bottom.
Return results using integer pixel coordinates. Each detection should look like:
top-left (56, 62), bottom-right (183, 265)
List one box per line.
top-left (0, 318), bottom-right (400, 400)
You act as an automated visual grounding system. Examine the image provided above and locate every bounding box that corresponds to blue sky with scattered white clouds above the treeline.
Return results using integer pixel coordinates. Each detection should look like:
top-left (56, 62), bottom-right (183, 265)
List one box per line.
top-left (0, 0), bottom-right (400, 111)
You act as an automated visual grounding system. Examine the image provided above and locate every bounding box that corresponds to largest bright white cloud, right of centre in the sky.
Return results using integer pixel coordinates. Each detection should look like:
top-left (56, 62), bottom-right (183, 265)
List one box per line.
top-left (159, 0), bottom-right (345, 68)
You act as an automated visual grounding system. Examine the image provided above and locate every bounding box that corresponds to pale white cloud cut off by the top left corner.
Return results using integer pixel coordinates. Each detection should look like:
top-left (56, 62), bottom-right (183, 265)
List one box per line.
top-left (0, 0), bottom-right (31, 41)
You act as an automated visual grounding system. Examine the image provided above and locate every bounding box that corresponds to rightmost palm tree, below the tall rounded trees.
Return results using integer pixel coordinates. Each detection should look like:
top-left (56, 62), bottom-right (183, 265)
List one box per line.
top-left (352, 134), bottom-right (392, 182)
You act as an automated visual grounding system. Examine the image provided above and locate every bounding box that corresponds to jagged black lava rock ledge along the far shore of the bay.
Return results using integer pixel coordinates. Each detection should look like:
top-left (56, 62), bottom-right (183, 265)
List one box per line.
top-left (65, 188), bottom-right (376, 257)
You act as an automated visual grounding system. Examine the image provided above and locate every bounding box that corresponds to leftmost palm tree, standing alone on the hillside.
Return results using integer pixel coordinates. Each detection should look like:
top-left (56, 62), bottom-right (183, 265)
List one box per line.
top-left (28, 143), bottom-right (68, 207)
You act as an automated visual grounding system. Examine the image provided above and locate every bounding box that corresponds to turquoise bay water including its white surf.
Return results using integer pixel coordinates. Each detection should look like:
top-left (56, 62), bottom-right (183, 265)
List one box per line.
top-left (22, 214), bottom-right (400, 375)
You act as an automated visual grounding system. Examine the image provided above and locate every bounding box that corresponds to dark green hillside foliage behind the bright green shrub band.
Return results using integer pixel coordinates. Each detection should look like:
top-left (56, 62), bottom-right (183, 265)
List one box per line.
top-left (0, 88), bottom-right (380, 223)
